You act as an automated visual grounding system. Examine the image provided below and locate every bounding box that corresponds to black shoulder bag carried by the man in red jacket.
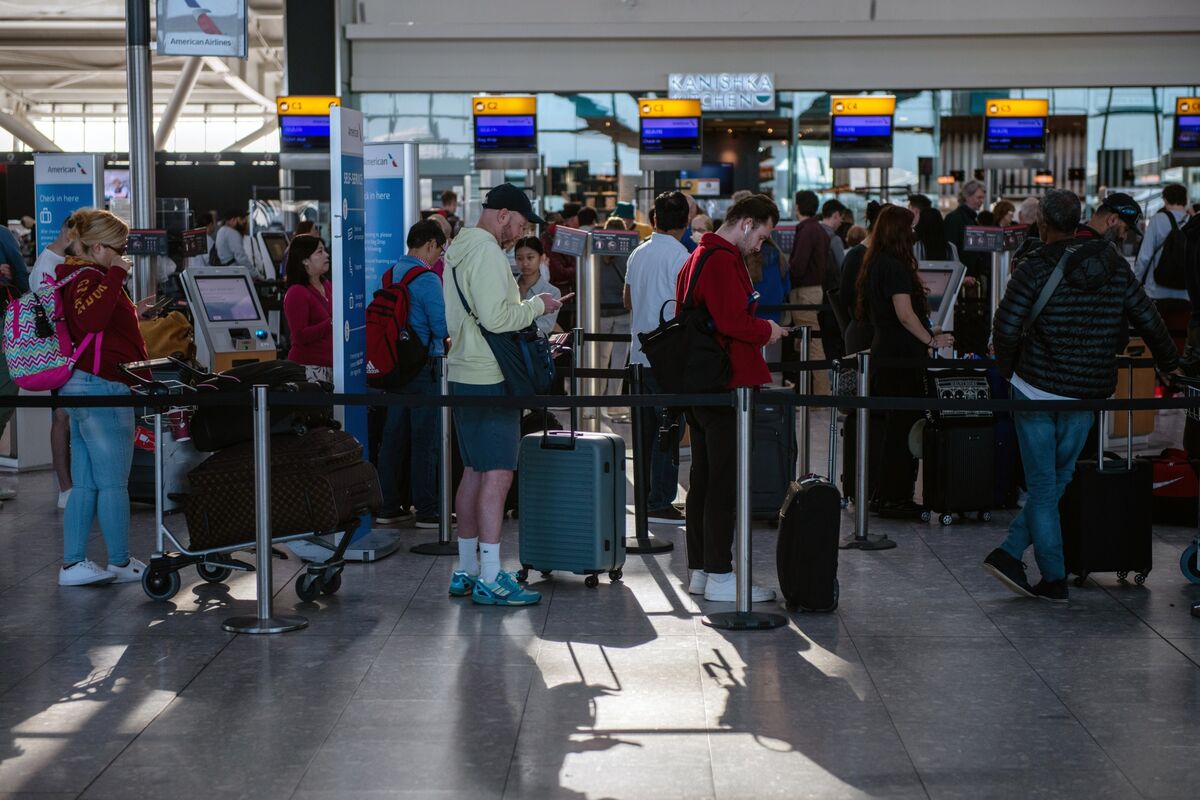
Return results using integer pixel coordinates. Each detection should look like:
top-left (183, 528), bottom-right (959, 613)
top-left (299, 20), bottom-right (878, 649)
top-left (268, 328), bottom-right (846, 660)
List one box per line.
top-left (637, 249), bottom-right (732, 395)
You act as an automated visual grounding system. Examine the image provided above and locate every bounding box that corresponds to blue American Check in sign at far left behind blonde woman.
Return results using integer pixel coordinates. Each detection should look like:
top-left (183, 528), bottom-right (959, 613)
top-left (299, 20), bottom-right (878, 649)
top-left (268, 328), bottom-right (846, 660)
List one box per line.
top-left (34, 152), bottom-right (104, 253)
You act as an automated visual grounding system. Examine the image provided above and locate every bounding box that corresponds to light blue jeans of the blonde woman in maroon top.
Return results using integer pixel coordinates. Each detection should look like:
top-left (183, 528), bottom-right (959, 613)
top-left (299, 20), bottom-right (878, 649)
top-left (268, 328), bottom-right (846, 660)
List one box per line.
top-left (59, 369), bottom-right (133, 564)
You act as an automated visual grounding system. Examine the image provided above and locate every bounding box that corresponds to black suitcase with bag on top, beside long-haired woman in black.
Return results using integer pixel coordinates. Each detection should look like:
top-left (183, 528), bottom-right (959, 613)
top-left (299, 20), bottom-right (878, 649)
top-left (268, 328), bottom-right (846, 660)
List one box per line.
top-left (922, 369), bottom-right (996, 525)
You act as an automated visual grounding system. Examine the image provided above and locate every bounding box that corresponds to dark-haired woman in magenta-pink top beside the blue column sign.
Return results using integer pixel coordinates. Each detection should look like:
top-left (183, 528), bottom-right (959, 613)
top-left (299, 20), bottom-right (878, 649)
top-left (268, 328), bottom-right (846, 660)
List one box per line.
top-left (283, 236), bottom-right (334, 379)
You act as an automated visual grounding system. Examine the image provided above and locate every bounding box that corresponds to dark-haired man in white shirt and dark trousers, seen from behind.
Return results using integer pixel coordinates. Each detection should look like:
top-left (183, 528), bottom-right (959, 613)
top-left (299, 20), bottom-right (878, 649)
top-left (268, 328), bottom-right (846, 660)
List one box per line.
top-left (624, 192), bottom-right (691, 524)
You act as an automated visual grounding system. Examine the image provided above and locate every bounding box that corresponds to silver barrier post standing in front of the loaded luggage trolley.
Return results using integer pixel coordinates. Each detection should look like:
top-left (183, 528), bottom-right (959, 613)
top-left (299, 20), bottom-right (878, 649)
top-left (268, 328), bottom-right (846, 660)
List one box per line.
top-left (224, 384), bottom-right (308, 633)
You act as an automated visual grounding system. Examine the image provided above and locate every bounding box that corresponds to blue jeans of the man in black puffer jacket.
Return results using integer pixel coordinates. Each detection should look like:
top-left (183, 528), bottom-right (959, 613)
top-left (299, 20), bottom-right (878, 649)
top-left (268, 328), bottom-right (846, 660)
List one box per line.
top-left (1001, 389), bottom-right (1093, 581)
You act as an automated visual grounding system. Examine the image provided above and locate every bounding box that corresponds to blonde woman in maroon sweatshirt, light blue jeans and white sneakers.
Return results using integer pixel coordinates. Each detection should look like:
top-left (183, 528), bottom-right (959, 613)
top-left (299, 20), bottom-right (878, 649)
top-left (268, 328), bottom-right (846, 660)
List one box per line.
top-left (55, 209), bottom-right (154, 587)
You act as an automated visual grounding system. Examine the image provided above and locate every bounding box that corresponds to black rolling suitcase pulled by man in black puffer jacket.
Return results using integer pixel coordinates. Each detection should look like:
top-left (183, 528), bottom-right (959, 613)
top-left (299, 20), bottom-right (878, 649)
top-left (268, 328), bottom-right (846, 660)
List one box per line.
top-left (1058, 407), bottom-right (1154, 585)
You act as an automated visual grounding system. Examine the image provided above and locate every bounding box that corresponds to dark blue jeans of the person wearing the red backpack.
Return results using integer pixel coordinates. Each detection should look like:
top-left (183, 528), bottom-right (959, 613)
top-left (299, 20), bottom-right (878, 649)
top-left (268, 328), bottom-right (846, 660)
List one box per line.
top-left (379, 367), bottom-right (442, 517)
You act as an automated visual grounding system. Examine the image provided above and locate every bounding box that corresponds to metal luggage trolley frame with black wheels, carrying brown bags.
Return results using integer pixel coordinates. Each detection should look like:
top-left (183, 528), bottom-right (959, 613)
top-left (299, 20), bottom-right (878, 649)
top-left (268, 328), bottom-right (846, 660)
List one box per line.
top-left (121, 357), bottom-right (359, 602)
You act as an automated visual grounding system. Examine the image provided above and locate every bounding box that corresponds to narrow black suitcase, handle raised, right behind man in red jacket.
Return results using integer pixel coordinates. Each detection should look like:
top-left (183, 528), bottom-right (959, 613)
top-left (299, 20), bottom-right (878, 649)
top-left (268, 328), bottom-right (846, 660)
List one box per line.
top-left (775, 376), bottom-right (841, 612)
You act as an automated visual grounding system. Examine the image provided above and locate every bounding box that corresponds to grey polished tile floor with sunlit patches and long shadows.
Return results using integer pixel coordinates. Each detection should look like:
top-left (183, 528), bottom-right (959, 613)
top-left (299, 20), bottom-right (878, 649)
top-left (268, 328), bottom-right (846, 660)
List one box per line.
top-left (0, 412), bottom-right (1200, 800)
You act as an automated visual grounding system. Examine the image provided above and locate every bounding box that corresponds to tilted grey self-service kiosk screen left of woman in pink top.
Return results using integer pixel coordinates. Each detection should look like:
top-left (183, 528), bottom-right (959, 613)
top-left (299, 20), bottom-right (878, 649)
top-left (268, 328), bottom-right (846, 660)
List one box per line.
top-left (182, 266), bottom-right (276, 372)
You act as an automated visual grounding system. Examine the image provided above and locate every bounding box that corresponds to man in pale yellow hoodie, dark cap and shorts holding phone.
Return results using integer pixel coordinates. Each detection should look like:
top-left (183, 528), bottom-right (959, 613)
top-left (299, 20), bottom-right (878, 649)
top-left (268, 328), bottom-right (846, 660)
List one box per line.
top-left (443, 184), bottom-right (570, 606)
